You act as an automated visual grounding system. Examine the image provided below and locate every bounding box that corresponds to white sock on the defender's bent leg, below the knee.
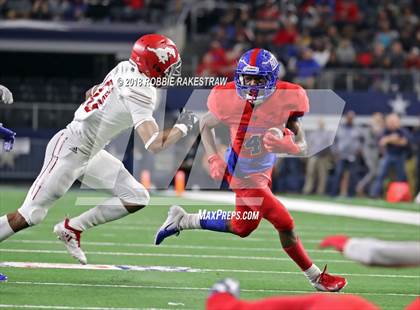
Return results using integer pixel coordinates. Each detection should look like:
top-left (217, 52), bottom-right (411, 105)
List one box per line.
top-left (69, 197), bottom-right (129, 231)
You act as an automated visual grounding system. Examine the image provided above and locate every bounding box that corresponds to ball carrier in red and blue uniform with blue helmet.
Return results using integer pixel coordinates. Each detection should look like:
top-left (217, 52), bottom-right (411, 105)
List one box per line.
top-left (155, 48), bottom-right (346, 291)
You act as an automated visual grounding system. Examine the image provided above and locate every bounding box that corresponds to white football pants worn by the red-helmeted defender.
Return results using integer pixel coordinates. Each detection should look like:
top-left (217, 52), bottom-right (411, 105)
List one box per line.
top-left (18, 129), bottom-right (150, 225)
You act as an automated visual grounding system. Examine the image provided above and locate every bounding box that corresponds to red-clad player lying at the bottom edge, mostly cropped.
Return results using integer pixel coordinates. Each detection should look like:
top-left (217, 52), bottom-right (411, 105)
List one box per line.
top-left (206, 279), bottom-right (379, 310)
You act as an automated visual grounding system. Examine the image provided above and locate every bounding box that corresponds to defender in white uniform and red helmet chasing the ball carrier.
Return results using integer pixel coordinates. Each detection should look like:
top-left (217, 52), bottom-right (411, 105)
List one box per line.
top-left (0, 34), bottom-right (198, 264)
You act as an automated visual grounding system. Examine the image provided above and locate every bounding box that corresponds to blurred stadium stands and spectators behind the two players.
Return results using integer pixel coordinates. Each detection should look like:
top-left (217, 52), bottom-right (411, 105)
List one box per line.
top-left (0, 0), bottom-right (420, 201)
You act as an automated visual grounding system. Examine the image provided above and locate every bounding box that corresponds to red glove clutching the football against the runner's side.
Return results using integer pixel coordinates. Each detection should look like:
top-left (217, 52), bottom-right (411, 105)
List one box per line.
top-left (263, 128), bottom-right (301, 155)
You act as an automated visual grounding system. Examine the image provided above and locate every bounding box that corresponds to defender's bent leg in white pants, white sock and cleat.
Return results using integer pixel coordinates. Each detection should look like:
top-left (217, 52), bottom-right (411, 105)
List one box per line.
top-left (54, 151), bottom-right (150, 263)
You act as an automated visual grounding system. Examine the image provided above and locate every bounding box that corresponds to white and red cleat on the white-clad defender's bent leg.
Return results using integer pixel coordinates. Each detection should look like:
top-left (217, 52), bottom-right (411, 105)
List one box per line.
top-left (54, 218), bottom-right (87, 265)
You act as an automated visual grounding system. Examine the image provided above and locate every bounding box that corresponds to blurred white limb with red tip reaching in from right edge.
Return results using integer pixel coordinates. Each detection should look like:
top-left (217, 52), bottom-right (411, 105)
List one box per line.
top-left (319, 235), bottom-right (420, 267)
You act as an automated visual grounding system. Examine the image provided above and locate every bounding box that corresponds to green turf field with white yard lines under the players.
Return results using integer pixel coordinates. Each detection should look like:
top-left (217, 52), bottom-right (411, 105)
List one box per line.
top-left (0, 187), bottom-right (420, 309)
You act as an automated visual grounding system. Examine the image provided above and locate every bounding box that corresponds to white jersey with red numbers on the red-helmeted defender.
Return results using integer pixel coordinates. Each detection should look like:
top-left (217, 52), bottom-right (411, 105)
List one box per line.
top-left (67, 61), bottom-right (156, 156)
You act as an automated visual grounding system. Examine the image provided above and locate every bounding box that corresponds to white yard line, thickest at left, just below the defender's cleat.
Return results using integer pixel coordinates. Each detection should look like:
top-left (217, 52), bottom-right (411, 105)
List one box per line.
top-left (0, 262), bottom-right (420, 279)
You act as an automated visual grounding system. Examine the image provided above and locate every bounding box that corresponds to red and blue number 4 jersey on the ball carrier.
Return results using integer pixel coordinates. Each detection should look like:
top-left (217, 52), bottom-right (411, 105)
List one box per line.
top-left (207, 81), bottom-right (309, 177)
